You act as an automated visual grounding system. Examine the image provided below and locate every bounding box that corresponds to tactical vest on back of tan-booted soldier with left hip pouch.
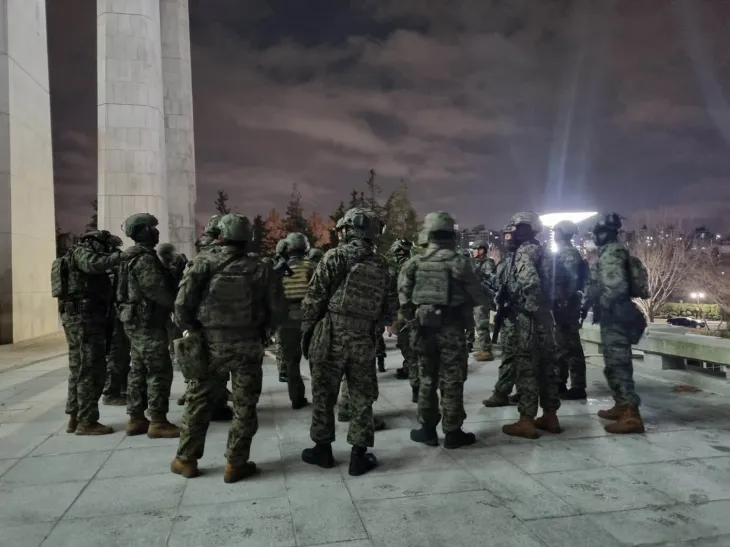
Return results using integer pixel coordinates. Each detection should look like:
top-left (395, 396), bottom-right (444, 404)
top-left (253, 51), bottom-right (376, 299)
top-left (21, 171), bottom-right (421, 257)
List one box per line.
top-left (197, 256), bottom-right (260, 329)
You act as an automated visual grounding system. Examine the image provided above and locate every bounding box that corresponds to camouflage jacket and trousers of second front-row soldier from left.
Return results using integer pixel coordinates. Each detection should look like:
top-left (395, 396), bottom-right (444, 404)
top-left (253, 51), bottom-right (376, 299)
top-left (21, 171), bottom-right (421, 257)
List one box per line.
top-left (117, 244), bottom-right (174, 420)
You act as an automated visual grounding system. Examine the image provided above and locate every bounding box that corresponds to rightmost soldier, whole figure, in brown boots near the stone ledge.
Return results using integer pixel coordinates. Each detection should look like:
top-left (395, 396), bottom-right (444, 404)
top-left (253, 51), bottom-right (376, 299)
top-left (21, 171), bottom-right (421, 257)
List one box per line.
top-left (585, 213), bottom-right (648, 433)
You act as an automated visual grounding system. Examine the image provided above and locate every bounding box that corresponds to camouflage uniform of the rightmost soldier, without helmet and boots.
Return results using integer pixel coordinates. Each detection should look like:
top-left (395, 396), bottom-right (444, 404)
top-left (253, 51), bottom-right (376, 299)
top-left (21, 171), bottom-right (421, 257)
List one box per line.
top-left (589, 242), bottom-right (641, 408)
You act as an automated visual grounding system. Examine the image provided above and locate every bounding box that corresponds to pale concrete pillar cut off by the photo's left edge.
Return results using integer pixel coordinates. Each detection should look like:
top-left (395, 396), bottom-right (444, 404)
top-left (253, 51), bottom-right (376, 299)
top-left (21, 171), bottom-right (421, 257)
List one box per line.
top-left (0, 0), bottom-right (58, 344)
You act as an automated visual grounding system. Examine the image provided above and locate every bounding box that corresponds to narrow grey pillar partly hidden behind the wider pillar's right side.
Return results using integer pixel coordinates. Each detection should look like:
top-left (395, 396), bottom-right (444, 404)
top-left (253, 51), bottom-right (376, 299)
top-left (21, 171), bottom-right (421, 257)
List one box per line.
top-left (160, 0), bottom-right (196, 258)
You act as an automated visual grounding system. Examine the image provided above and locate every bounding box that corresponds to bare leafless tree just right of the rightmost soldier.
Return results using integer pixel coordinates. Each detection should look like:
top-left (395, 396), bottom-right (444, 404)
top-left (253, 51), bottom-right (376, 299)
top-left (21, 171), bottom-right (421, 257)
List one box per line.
top-left (628, 224), bottom-right (698, 323)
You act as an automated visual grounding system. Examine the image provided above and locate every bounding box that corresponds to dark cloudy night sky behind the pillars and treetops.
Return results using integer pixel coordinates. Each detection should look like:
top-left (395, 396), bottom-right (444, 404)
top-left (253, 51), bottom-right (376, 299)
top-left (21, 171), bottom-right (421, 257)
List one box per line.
top-left (48, 0), bottom-right (730, 235)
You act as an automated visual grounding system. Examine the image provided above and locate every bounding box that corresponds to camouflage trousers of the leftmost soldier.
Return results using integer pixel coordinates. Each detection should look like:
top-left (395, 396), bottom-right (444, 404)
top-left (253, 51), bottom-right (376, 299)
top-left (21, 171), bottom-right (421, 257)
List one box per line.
top-left (61, 312), bottom-right (106, 425)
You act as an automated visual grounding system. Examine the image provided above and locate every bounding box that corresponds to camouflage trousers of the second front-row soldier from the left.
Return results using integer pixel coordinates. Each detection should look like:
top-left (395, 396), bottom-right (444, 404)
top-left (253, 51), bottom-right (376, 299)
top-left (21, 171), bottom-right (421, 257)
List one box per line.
top-left (124, 324), bottom-right (173, 419)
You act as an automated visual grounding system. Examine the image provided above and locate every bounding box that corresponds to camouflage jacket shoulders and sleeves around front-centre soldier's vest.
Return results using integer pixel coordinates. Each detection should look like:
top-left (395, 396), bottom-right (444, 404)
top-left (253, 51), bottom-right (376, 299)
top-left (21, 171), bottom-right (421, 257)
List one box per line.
top-left (301, 240), bottom-right (398, 332)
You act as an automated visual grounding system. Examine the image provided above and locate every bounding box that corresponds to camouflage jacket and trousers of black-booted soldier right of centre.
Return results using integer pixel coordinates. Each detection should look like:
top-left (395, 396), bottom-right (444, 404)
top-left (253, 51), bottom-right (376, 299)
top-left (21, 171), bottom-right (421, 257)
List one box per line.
top-left (398, 243), bottom-right (484, 433)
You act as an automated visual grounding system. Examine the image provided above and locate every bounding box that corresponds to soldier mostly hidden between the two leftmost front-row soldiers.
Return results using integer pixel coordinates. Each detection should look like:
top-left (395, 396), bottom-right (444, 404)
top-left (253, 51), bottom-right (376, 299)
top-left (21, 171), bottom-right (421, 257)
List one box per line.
top-left (102, 235), bottom-right (132, 406)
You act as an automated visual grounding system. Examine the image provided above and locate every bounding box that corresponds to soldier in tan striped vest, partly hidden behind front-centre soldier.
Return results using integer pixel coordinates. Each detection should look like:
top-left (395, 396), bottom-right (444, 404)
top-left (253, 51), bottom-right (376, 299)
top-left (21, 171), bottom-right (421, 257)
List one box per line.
top-left (277, 233), bottom-right (315, 410)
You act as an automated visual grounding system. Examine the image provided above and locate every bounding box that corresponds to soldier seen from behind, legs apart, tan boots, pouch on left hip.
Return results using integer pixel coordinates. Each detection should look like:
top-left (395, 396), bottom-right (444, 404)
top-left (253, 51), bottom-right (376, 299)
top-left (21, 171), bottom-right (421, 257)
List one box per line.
top-left (170, 213), bottom-right (281, 483)
